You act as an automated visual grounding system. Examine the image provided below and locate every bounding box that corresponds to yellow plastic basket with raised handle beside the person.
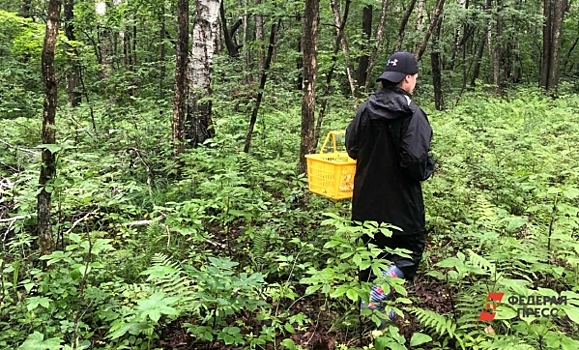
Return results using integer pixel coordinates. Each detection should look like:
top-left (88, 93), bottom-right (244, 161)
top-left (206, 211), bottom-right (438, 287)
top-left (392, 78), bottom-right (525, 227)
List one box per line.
top-left (306, 131), bottom-right (356, 200)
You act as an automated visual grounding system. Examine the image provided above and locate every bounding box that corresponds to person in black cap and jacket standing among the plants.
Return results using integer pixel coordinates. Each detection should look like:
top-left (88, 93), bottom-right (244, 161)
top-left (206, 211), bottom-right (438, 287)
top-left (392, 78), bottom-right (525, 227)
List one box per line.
top-left (346, 52), bottom-right (434, 320)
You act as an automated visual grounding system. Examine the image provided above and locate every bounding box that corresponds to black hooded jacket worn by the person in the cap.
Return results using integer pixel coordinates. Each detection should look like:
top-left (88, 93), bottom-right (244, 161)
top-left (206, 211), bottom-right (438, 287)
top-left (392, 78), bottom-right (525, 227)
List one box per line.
top-left (346, 88), bottom-right (434, 235)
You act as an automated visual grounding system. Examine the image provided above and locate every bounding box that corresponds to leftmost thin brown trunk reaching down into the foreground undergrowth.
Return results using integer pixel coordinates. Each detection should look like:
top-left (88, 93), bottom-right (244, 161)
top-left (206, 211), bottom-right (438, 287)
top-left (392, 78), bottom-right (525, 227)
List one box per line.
top-left (37, 0), bottom-right (62, 256)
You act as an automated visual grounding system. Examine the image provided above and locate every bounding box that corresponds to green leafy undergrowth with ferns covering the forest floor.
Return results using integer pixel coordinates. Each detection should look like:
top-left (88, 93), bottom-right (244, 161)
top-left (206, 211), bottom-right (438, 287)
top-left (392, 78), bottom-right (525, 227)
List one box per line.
top-left (0, 88), bottom-right (579, 350)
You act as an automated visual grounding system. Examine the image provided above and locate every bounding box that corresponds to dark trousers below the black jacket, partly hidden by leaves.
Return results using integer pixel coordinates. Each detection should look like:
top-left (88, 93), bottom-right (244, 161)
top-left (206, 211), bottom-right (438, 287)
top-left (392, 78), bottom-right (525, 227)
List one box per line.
top-left (359, 232), bottom-right (426, 282)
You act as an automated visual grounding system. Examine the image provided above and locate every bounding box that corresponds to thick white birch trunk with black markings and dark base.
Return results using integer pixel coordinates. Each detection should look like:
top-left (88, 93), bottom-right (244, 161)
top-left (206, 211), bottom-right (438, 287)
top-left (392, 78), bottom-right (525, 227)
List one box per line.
top-left (185, 0), bottom-right (221, 147)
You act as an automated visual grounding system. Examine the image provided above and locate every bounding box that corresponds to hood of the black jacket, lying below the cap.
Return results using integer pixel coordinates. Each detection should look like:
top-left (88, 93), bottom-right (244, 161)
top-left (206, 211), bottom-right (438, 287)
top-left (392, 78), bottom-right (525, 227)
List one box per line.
top-left (366, 88), bottom-right (413, 119)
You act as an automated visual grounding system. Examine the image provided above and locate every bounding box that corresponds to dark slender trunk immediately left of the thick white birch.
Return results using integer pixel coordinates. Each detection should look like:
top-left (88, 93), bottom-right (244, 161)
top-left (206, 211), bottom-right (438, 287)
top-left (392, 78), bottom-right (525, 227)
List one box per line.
top-left (172, 0), bottom-right (189, 156)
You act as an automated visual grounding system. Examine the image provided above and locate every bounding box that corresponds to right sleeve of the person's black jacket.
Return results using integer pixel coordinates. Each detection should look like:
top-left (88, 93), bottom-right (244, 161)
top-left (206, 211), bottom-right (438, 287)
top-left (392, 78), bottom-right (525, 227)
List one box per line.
top-left (400, 110), bottom-right (435, 181)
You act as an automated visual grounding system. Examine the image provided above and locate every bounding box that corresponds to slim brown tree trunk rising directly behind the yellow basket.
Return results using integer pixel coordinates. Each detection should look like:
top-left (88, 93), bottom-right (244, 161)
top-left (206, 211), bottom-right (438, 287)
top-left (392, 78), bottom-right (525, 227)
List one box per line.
top-left (299, 0), bottom-right (320, 172)
